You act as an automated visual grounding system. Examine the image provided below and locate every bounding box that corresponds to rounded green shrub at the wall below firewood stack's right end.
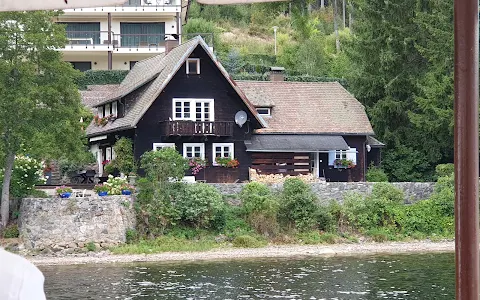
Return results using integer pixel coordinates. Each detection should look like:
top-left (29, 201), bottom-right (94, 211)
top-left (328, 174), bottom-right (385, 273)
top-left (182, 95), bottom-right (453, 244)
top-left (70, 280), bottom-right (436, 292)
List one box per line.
top-left (280, 178), bottom-right (317, 231)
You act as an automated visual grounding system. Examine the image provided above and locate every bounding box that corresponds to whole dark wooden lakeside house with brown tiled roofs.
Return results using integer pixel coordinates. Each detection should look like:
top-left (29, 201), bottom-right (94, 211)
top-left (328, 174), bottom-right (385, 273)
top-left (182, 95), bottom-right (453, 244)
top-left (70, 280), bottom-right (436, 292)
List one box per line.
top-left (82, 37), bottom-right (384, 182)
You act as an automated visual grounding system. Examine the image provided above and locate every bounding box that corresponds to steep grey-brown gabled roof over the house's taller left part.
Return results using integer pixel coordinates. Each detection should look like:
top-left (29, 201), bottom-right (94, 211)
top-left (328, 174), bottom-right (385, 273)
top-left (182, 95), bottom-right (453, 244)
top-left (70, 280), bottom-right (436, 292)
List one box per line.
top-left (87, 36), bottom-right (267, 136)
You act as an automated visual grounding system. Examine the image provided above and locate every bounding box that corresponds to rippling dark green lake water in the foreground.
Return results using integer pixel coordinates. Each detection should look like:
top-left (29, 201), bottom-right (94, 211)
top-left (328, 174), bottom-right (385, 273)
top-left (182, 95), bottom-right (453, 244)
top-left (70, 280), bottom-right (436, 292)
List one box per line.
top-left (41, 253), bottom-right (455, 300)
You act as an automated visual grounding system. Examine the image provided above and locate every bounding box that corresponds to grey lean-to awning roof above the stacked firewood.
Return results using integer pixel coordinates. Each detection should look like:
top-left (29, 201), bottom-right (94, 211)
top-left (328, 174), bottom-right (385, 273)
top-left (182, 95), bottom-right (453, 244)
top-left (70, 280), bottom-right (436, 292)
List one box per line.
top-left (245, 134), bottom-right (349, 152)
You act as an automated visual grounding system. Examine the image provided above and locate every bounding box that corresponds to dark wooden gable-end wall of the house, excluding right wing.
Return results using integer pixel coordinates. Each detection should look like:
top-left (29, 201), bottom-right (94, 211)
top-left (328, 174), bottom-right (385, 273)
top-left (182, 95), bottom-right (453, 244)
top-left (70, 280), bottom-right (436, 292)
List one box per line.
top-left (135, 47), bottom-right (261, 182)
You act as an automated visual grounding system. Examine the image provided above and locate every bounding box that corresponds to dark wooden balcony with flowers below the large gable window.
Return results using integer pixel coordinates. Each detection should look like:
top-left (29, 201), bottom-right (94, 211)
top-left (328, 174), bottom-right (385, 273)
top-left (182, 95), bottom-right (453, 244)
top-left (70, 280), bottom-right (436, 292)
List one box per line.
top-left (161, 121), bottom-right (234, 136)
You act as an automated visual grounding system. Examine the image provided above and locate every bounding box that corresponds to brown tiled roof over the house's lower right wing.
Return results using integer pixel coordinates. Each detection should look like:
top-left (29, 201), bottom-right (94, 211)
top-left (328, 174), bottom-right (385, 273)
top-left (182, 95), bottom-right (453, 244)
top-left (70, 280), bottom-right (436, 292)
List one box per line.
top-left (237, 81), bottom-right (374, 135)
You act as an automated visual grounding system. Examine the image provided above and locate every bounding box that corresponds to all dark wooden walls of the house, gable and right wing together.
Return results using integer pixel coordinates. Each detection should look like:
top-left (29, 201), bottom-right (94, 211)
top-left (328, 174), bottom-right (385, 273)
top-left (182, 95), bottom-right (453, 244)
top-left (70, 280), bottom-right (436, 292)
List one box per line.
top-left (92, 46), bottom-right (379, 182)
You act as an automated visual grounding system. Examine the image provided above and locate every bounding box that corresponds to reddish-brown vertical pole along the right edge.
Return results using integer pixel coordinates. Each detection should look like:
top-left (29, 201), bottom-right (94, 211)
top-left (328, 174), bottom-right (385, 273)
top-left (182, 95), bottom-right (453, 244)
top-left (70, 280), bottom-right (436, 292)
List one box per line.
top-left (454, 0), bottom-right (479, 300)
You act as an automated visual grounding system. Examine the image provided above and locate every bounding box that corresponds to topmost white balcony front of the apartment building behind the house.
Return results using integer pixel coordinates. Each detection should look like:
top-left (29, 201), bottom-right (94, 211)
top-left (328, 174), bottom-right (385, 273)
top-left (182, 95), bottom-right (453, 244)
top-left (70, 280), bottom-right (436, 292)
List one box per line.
top-left (60, 0), bottom-right (182, 16)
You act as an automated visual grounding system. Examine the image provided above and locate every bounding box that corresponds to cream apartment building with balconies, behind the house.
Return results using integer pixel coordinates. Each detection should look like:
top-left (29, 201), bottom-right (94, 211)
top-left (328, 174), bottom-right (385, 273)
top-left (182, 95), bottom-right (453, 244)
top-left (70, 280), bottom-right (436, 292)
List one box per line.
top-left (56, 0), bottom-right (183, 71)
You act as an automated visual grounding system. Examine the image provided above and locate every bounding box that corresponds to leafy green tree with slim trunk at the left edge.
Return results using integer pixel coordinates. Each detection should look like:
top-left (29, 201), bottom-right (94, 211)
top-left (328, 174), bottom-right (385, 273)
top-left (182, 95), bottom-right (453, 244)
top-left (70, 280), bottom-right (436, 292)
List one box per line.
top-left (0, 11), bottom-right (85, 226)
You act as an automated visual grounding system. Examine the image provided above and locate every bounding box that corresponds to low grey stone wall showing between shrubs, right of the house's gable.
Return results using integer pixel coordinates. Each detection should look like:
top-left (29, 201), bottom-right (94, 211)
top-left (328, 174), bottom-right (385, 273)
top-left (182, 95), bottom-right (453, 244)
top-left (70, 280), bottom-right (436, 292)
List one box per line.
top-left (211, 182), bottom-right (435, 204)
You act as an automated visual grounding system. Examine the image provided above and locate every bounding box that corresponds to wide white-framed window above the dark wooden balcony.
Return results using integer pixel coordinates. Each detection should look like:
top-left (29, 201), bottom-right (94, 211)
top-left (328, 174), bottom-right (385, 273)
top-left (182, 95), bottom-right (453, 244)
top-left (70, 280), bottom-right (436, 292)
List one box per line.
top-left (172, 98), bottom-right (215, 122)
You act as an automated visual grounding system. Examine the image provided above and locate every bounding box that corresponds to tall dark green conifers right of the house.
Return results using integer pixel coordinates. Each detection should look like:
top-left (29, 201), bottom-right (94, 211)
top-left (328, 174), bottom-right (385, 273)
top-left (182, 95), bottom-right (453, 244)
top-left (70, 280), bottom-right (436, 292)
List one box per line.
top-left (347, 0), bottom-right (453, 181)
